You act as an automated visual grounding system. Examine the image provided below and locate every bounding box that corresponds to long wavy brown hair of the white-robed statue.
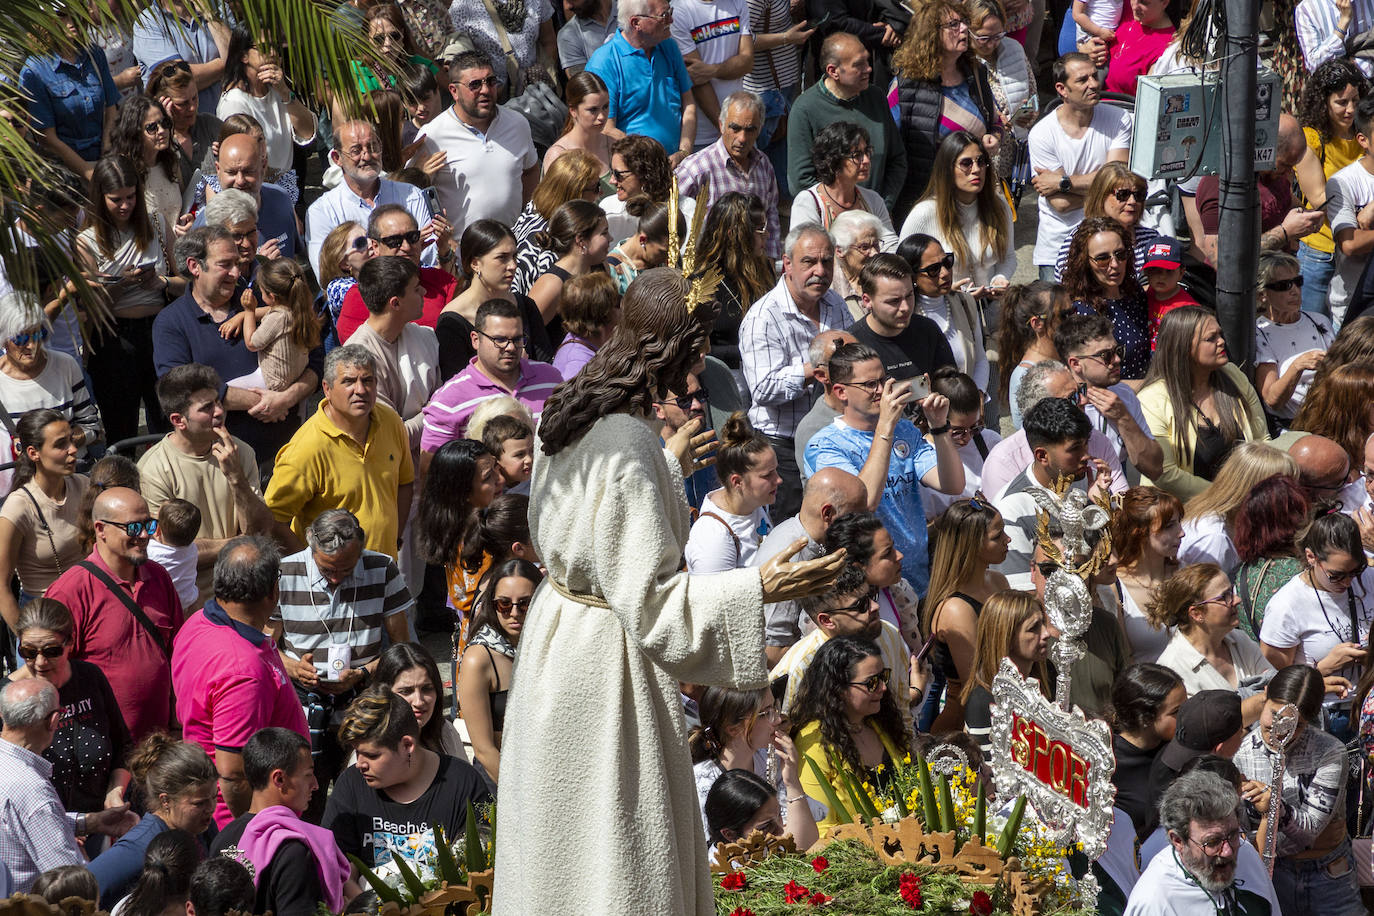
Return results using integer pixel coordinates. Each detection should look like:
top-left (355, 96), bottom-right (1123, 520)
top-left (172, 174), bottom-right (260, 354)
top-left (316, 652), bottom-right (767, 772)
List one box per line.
top-left (539, 268), bottom-right (716, 455)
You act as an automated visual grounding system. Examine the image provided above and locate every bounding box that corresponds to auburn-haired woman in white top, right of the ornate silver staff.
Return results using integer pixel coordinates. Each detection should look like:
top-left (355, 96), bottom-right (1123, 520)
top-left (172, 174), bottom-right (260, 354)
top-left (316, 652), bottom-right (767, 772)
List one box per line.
top-left (1112, 486), bottom-right (1183, 662)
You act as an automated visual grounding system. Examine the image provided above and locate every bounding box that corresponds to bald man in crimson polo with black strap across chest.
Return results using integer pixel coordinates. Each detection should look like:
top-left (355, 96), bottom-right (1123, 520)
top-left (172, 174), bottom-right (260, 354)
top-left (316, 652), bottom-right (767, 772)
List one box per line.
top-left (45, 486), bottom-right (184, 740)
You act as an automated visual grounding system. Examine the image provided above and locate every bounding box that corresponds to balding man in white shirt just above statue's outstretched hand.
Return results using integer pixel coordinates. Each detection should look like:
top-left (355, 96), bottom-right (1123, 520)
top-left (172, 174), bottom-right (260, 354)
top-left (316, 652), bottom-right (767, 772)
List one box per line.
top-left (750, 469), bottom-right (868, 667)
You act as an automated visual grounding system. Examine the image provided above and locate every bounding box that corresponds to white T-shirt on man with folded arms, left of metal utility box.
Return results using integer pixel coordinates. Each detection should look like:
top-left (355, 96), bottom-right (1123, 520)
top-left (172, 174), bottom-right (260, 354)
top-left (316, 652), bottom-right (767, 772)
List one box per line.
top-left (1028, 104), bottom-right (1134, 266)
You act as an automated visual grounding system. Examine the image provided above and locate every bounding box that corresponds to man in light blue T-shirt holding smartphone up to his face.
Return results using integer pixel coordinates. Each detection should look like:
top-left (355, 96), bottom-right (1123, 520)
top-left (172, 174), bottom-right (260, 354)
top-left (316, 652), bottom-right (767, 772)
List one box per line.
top-left (804, 343), bottom-right (963, 595)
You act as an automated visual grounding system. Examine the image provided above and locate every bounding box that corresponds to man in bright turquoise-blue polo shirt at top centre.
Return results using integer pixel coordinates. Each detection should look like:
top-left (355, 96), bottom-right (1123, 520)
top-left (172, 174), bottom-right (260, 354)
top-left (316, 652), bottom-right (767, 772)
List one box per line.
top-left (587, 0), bottom-right (697, 168)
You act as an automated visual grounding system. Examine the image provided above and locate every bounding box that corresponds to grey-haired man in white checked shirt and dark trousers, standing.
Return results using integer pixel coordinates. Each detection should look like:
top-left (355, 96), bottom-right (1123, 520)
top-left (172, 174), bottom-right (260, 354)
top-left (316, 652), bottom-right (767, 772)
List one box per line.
top-left (739, 222), bottom-right (852, 518)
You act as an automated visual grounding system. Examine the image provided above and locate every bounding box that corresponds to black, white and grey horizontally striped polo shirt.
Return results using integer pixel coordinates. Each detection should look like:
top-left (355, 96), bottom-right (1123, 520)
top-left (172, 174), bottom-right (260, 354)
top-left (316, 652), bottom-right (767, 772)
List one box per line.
top-left (280, 548), bottom-right (415, 667)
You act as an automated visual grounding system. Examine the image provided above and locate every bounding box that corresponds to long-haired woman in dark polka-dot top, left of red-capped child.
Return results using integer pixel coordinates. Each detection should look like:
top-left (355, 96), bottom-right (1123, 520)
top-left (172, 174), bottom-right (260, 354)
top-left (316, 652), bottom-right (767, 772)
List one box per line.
top-left (1063, 217), bottom-right (1150, 379)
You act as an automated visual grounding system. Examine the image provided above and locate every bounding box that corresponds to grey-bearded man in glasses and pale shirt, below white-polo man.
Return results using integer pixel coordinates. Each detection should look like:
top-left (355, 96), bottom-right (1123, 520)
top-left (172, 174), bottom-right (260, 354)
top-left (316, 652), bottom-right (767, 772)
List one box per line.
top-left (305, 119), bottom-right (439, 276)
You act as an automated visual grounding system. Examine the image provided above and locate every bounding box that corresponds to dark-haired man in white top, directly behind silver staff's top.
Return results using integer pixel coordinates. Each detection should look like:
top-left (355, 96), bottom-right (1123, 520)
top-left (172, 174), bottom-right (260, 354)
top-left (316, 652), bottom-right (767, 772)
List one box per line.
top-left (994, 397), bottom-right (1112, 592)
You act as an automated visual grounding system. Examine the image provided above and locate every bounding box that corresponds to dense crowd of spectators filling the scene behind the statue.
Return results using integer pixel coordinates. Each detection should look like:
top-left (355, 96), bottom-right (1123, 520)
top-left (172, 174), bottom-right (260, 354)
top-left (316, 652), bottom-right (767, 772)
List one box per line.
top-left (0, 0), bottom-right (1374, 916)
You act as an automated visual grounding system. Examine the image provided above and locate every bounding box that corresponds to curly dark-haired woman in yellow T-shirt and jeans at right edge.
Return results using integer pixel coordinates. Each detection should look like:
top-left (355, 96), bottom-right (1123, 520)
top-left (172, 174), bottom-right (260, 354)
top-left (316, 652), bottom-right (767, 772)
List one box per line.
top-left (1294, 58), bottom-right (1370, 314)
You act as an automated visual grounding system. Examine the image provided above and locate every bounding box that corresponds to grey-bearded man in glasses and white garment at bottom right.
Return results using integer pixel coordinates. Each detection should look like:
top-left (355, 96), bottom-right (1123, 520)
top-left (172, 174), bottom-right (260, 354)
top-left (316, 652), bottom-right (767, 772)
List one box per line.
top-left (1125, 770), bottom-right (1279, 916)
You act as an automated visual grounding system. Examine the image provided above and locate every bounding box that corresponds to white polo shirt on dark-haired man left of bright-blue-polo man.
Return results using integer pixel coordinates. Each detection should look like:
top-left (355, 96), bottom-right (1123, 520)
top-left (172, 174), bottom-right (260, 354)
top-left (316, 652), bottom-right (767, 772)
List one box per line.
top-left (420, 107), bottom-right (539, 239)
